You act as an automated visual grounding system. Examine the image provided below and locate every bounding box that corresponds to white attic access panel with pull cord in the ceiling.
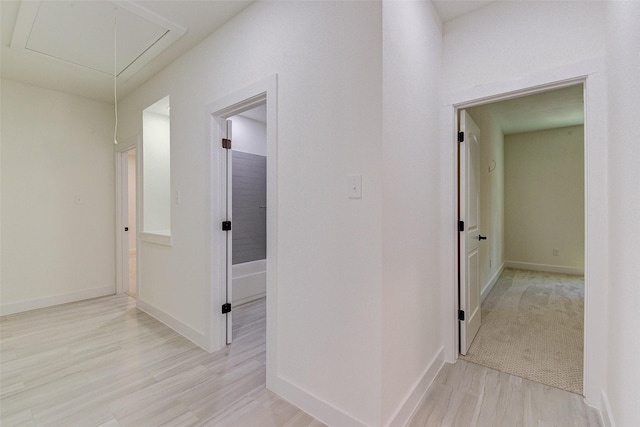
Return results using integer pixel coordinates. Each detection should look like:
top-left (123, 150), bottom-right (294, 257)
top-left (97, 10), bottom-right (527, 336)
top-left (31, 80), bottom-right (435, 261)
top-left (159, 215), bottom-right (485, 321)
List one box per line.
top-left (11, 0), bottom-right (185, 78)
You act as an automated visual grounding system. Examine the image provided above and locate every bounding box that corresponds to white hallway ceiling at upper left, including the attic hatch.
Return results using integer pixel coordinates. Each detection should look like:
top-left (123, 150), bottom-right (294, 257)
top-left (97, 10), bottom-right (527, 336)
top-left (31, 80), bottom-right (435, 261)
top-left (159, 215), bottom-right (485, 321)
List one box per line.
top-left (0, 0), bottom-right (252, 103)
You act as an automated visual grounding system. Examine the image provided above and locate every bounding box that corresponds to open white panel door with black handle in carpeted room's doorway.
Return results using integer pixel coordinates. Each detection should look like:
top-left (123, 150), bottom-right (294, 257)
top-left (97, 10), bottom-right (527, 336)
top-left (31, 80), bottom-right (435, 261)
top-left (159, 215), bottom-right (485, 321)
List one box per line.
top-left (458, 110), bottom-right (486, 354)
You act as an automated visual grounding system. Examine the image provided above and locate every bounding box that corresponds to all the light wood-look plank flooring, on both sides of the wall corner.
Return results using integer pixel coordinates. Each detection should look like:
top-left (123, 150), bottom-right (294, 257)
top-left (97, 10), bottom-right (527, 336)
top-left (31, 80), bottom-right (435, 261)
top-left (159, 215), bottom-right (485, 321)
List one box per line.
top-left (0, 295), bottom-right (600, 427)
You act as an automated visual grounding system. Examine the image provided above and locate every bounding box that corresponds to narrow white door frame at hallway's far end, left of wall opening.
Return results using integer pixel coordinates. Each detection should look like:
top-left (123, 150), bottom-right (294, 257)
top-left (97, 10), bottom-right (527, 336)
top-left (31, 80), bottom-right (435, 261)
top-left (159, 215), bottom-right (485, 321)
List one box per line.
top-left (115, 135), bottom-right (140, 295)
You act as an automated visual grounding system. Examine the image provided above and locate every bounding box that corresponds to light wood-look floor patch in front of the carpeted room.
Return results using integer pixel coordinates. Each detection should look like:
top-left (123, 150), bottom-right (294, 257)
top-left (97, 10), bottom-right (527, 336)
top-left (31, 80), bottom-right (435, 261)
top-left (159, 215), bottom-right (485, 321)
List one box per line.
top-left (409, 360), bottom-right (602, 427)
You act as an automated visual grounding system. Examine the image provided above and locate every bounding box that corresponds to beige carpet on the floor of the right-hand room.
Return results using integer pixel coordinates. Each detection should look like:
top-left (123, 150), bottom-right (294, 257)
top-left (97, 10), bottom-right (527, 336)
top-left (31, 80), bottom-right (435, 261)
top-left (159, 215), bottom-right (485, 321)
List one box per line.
top-left (460, 269), bottom-right (584, 394)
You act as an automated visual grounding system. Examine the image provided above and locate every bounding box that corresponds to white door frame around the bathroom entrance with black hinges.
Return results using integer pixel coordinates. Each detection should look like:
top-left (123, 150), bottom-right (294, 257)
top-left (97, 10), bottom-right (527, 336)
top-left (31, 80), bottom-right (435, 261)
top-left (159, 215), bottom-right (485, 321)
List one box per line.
top-left (206, 74), bottom-right (278, 388)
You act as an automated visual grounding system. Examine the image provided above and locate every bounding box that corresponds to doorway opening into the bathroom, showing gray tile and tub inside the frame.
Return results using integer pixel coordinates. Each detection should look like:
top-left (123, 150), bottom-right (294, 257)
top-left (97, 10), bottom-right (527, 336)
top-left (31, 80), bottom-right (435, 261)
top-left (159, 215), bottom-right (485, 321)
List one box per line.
top-left (221, 105), bottom-right (268, 344)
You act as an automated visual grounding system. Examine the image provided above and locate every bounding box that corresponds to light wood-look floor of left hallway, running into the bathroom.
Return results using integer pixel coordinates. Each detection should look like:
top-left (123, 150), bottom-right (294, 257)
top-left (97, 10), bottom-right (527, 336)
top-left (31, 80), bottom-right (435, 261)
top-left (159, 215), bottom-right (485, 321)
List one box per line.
top-left (0, 295), bottom-right (324, 427)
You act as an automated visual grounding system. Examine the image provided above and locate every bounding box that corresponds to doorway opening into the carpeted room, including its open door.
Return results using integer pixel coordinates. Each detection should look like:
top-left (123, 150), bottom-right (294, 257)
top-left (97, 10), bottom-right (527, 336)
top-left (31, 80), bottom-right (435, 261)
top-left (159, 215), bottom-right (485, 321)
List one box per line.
top-left (458, 82), bottom-right (586, 394)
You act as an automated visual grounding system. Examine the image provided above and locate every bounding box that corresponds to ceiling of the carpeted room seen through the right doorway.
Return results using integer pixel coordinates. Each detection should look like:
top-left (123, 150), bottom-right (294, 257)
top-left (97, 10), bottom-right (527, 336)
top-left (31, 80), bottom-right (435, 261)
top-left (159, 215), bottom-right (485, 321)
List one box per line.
top-left (468, 84), bottom-right (584, 135)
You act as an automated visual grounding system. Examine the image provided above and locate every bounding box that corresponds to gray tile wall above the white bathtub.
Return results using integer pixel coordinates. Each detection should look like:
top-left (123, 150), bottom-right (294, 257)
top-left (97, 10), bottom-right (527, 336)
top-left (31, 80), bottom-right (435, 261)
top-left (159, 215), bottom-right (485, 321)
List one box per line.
top-left (232, 151), bottom-right (267, 264)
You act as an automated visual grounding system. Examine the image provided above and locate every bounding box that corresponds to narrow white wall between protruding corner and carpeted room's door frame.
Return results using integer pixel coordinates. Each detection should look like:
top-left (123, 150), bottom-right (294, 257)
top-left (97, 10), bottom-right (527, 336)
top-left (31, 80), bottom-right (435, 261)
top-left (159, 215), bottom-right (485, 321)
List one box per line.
top-left (382, 2), bottom-right (443, 425)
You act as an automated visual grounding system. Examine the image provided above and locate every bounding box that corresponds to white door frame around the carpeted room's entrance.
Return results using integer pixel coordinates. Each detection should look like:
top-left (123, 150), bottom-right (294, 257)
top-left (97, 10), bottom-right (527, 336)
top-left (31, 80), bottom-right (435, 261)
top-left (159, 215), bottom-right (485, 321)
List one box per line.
top-left (441, 58), bottom-right (608, 408)
